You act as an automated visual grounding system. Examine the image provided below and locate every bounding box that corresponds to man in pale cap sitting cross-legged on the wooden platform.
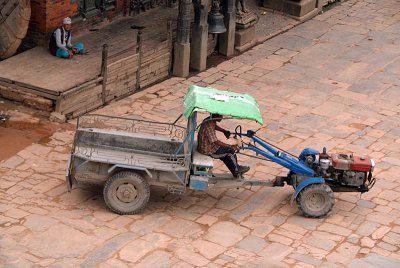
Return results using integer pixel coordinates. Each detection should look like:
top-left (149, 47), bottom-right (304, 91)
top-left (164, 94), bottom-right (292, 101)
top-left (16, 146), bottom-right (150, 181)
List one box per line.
top-left (49, 17), bottom-right (86, 59)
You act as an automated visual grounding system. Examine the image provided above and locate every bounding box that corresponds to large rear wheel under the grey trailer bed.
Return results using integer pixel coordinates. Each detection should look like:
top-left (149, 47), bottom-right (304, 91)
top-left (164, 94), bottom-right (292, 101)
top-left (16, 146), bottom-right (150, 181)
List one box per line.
top-left (103, 171), bottom-right (150, 215)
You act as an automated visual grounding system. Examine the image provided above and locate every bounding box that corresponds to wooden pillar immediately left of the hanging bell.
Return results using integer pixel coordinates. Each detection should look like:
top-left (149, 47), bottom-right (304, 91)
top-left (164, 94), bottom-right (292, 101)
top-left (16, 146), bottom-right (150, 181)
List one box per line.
top-left (190, 0), bottom-right (210, 71)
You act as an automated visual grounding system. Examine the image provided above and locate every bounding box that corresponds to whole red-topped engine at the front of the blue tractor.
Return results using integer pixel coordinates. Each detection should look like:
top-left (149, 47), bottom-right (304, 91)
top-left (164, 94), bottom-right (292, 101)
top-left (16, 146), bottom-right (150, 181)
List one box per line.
top-left (319, 152), bottom-right (375, 187)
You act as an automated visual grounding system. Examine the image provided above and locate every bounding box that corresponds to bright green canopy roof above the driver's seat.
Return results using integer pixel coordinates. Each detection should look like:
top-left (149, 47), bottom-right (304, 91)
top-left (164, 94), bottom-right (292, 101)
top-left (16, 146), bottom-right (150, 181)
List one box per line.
top-left (183, 85), bottom-right (263, 125)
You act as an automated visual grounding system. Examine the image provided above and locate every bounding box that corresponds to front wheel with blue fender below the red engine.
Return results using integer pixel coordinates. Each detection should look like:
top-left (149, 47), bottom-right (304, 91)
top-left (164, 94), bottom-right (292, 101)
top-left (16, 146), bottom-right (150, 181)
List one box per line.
top-left (296, 183), bottom-right (335, 218)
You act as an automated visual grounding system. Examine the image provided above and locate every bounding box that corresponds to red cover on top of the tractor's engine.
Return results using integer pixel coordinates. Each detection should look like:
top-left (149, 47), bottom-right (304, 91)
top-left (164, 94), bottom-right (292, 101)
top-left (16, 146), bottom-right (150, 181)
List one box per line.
top-left (331, 154), bottom-right (372, 172)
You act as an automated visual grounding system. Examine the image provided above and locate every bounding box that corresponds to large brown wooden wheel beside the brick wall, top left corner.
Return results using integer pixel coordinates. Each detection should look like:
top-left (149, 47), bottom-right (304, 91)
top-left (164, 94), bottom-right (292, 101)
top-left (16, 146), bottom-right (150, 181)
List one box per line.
top-left (0, 0), bottom-right (31, 59)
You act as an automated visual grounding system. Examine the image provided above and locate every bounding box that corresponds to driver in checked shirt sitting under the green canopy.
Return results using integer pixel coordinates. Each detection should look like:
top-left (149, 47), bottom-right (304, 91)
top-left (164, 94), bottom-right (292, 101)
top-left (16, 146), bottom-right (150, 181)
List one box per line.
top-left (197, 114), bottom-right (250, 178)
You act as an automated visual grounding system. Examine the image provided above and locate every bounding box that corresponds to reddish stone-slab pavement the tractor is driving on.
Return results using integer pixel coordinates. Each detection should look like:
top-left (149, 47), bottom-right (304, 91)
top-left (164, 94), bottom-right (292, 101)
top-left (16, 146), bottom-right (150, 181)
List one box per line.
top-left (0, 0), bottom-right (400, 267)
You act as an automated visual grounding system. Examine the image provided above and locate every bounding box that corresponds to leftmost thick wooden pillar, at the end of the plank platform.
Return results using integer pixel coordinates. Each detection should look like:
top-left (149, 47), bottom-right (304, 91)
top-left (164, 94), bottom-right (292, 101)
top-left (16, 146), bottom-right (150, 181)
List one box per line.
top-left (173, 0), bottom-right (192, 77)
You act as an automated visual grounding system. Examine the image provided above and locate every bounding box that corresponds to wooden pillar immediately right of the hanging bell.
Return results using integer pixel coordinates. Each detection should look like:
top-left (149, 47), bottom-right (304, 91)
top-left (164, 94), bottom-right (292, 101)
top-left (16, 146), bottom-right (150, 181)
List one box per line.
top-left (219, 0), bottom-right (236, 56)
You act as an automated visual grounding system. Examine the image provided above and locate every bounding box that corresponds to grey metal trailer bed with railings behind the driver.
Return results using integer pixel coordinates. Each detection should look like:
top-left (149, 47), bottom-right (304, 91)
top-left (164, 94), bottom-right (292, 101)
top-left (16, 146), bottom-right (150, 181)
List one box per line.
top-left (67, 115), bottom-right (193, 213)
